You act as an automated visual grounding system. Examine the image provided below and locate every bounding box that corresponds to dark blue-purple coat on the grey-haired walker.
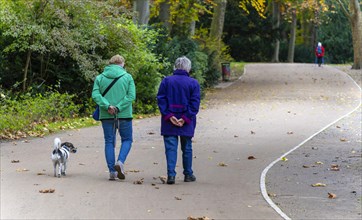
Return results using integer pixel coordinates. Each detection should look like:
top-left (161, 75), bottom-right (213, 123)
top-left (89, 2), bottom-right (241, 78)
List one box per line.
top-left (157, 70), bottom-right (200, 137)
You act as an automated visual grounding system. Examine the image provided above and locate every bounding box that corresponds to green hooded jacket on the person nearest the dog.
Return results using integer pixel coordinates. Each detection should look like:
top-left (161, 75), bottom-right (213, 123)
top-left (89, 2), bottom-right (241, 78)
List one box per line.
top-left (92, 64), bottom-right (136, 120)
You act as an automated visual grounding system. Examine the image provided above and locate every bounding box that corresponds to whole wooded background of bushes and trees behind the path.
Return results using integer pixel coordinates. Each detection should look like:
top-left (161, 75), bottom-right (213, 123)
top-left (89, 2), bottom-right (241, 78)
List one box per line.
top-left (0, 0), bottom-right (362, 117)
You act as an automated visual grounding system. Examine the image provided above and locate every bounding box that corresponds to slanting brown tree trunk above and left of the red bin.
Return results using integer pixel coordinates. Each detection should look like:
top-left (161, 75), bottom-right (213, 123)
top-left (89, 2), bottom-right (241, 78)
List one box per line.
top-left (210, 0), bottom-right (227, 40)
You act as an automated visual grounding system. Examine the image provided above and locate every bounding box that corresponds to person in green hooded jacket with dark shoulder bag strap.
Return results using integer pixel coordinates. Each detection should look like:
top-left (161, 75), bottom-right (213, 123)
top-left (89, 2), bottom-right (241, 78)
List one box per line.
top-left (92, 55), bottom-right (136, 180)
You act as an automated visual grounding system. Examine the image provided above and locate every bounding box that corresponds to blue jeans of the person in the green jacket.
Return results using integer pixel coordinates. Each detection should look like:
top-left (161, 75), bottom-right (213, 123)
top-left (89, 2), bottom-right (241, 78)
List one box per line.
top-left (102, 119), bottom-right (133, 172)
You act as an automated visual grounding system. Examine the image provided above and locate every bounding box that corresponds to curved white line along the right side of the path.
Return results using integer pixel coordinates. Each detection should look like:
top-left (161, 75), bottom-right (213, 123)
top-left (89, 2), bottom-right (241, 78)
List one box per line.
top-left (260, 67), bottom-right (362, 220)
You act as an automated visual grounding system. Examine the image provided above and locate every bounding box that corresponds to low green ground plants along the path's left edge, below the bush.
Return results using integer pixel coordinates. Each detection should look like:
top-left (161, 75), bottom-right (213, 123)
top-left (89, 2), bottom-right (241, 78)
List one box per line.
top-left (0, 88), bottom-right (80, 138)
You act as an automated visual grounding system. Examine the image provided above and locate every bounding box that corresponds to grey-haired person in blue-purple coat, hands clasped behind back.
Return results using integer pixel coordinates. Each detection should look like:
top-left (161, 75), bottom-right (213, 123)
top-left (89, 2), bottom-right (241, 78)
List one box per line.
top-left (157, 56), bottom-right (200, 184)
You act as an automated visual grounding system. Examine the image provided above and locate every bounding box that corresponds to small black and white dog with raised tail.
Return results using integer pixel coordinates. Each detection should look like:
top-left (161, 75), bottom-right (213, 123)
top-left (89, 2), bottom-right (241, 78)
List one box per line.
top-left (52, 138), bottom-right (77, 177)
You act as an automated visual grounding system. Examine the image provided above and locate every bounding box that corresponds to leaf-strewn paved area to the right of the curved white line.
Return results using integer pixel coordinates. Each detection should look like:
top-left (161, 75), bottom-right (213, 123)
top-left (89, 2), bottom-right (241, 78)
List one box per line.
top-left (260, 67), bottom-right (362, 219)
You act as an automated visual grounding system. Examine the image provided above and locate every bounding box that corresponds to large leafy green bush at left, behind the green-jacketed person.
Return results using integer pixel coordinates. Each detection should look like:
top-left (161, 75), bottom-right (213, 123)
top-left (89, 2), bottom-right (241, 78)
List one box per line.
top-left (0, 0), bottom-right (163, 114)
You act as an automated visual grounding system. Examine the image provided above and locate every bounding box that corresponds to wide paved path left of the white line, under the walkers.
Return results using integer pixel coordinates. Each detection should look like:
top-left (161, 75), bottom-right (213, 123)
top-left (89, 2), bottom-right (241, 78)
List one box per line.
top-left (0, 64), bottom-right (359, 219)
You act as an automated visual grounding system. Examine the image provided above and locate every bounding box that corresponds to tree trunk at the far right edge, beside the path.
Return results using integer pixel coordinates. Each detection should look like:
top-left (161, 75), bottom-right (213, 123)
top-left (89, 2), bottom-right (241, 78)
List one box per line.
top-left (349, 0), bottom-right (362, 69)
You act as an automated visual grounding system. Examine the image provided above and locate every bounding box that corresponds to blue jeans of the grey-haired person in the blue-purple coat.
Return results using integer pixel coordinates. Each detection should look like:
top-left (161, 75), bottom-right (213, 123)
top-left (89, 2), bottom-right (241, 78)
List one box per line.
top-left (163, 135), bottom-right (193, 176)
